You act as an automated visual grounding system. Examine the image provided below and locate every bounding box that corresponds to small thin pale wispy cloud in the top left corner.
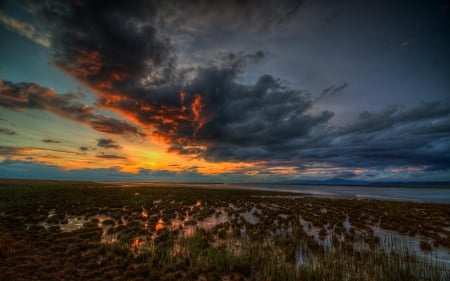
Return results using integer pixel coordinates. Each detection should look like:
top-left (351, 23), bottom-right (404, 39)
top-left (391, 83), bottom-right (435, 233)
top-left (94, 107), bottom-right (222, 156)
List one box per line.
top-left (0, 12), bottom-right (50, 48)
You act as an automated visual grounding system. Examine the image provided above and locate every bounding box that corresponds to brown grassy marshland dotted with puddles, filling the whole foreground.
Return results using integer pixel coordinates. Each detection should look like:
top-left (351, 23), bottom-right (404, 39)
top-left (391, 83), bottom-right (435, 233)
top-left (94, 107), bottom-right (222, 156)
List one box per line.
top-left (0, 180), bottom-right (450, 280)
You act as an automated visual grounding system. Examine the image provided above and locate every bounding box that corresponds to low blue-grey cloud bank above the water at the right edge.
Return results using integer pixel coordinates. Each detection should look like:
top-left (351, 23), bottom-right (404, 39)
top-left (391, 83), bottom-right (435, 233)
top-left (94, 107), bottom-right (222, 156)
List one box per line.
top-left (191, 98), bottom-right (450, 171)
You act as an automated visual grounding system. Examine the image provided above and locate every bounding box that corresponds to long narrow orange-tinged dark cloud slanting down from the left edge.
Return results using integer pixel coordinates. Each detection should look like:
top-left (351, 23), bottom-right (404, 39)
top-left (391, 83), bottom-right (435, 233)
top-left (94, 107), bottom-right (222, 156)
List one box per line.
top-left (0, 80), bottom-right (143, 136)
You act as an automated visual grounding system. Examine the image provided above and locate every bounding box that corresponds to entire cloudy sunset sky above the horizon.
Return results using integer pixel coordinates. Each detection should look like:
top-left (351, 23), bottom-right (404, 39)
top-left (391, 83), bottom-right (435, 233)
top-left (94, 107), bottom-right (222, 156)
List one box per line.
top-left (0, 0), bottom-right (450, 182)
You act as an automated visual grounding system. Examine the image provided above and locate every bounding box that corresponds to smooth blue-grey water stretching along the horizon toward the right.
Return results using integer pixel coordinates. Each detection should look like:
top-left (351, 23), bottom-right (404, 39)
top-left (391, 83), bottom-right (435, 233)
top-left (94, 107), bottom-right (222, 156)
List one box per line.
top-left (106, 182), bottom-right (450, 204)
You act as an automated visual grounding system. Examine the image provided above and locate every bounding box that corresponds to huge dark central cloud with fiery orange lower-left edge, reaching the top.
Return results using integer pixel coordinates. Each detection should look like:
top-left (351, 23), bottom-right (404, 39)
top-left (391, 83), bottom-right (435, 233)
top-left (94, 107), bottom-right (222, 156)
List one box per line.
top-left (15, 1), bottom-right (326, 161)
